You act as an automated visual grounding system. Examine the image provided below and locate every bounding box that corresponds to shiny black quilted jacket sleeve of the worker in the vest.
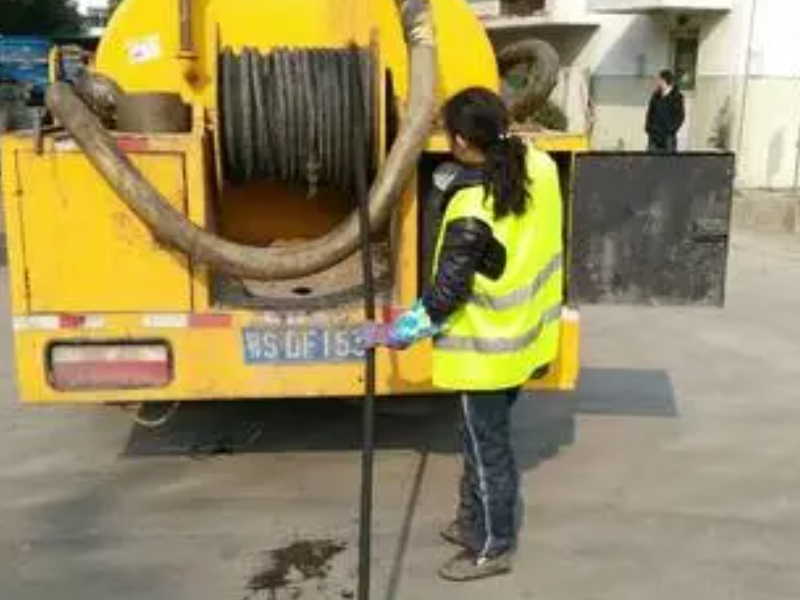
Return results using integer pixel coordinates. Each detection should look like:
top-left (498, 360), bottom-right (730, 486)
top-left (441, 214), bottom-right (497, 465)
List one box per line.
top-left (422, 217), bottom-right (494, 324)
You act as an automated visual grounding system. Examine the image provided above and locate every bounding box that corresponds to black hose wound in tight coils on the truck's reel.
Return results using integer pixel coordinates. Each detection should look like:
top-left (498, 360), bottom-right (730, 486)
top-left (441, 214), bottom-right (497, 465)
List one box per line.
top-left (218, 46), bottom-right (378, 196)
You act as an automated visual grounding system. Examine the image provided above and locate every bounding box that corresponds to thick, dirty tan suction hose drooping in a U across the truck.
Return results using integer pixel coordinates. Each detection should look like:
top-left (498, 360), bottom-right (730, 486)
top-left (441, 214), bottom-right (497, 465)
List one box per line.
top-left (47, 0), bottom-right (438, 281)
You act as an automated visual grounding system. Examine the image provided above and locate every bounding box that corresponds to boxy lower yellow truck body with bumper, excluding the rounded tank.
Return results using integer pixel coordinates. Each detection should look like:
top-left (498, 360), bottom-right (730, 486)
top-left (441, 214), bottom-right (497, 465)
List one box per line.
top-left (2, 126), bottom-right (585, 404)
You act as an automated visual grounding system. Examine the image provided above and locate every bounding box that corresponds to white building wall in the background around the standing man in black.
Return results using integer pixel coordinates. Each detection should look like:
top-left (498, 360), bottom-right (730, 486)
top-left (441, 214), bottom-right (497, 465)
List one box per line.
top-left (476, 0), bottom-right (800, 188)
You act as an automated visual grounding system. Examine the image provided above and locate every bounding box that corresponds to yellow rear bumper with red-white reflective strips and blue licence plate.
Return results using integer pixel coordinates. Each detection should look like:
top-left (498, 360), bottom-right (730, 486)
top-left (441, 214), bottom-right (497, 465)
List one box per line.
top-left (9, 309), bottom-right (580, 404)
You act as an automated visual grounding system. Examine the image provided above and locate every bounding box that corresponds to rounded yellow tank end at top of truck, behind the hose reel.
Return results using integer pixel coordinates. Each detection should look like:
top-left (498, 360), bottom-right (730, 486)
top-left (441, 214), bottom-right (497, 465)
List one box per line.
top-left (92, 0), bottom-right (499, 108)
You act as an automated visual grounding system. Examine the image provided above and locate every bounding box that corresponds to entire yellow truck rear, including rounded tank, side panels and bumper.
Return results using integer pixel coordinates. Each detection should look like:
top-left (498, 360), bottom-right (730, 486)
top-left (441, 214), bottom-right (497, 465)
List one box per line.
top-left (2, 0), bottom-right (587, 404)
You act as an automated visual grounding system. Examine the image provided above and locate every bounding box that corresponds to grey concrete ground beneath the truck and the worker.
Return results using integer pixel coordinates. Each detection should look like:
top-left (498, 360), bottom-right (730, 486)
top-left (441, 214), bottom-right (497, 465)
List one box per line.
top-left (0, 227), bottom-right (800, 600)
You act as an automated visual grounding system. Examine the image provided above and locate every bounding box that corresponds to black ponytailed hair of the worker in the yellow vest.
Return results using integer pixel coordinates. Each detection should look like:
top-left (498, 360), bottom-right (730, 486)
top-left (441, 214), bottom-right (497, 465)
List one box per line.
top-left (444, 87), bottom-right (531, 219)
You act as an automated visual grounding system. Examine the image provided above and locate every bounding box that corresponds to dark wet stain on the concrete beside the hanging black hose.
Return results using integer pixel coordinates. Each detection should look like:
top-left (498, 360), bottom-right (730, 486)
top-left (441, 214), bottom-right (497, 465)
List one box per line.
top-left (247, 540), bottom-right (352, 599)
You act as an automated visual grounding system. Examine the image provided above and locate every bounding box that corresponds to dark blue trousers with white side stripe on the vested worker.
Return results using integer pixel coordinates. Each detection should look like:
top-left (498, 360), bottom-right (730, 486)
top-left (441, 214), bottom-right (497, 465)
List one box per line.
top-left (457, 388), bottom-right (520, 558)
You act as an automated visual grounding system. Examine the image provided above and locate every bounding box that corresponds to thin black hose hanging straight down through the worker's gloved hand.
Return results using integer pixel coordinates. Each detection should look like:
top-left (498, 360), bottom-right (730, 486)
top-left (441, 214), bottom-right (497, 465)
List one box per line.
top-left (348, 47), bottom-right (376, 600)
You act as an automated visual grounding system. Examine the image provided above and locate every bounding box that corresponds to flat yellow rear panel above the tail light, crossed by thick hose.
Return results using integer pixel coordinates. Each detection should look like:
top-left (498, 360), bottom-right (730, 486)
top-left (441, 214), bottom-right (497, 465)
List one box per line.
top-left (9, 138), bottom-right (191, 313)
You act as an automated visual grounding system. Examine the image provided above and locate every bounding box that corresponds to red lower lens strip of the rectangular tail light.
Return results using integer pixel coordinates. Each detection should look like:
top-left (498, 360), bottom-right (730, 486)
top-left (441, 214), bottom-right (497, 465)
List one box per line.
top-left (50, 361), bottom-right (170, 390)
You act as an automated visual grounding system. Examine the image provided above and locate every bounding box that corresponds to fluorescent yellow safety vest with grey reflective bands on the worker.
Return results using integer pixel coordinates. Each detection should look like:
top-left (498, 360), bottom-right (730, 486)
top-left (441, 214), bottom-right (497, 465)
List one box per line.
top-left (433, 148), bottom-right (564, 390)
